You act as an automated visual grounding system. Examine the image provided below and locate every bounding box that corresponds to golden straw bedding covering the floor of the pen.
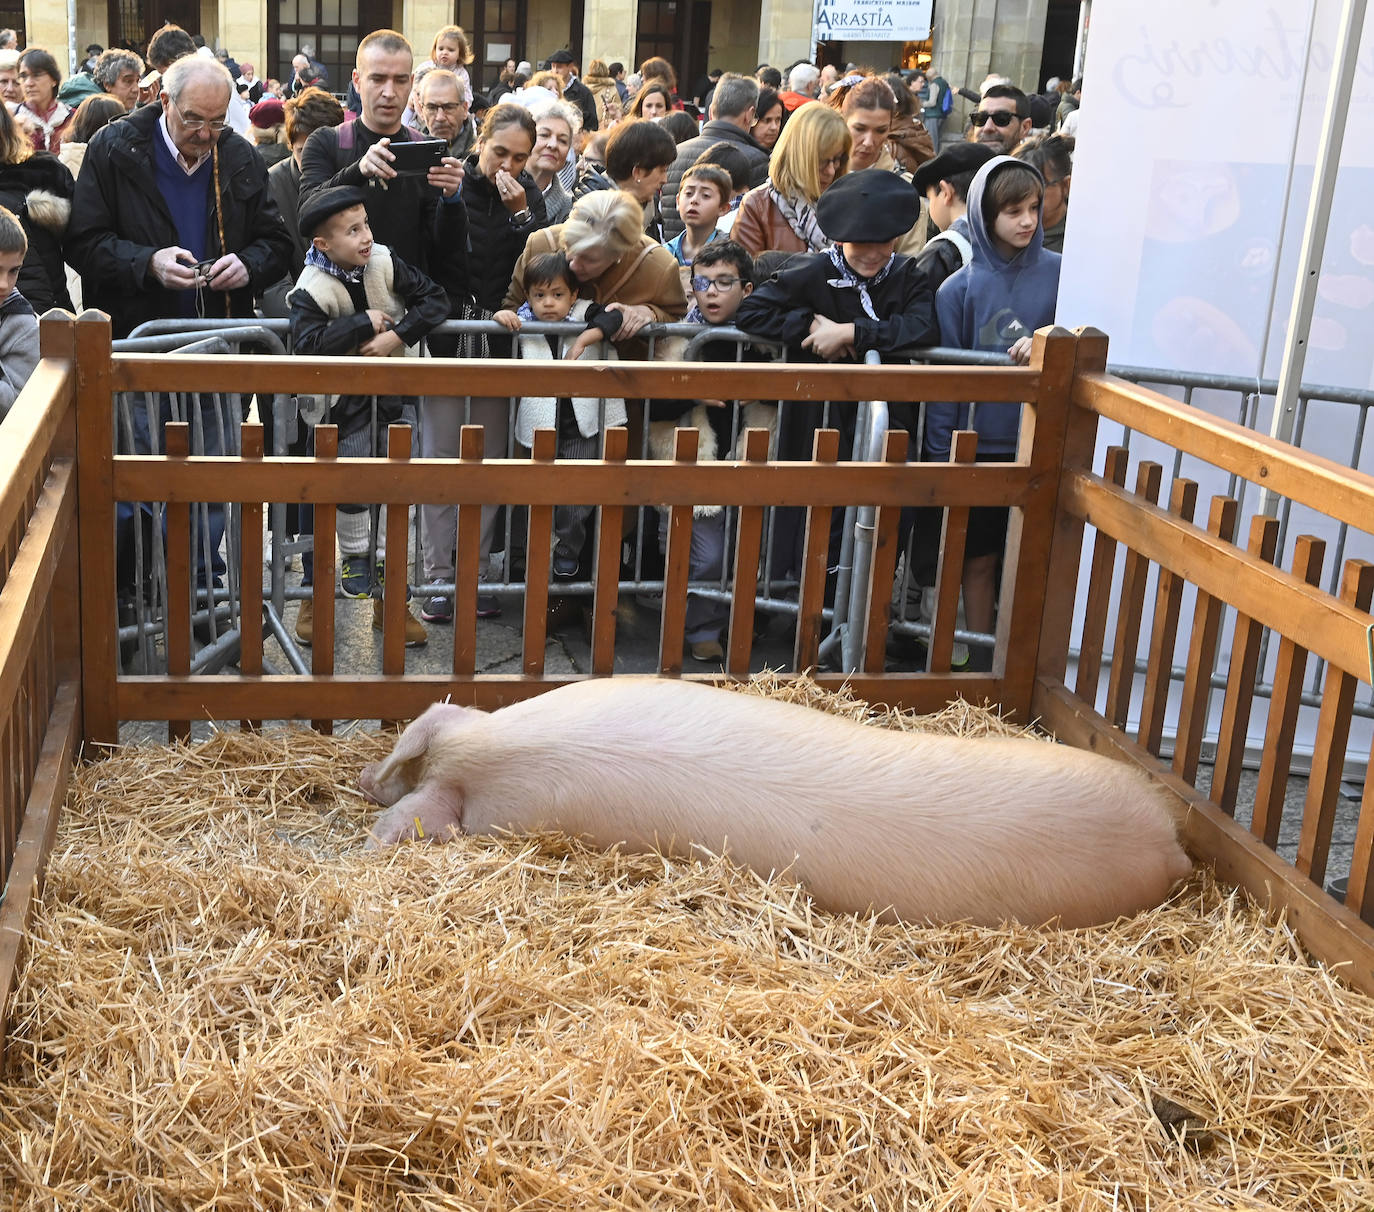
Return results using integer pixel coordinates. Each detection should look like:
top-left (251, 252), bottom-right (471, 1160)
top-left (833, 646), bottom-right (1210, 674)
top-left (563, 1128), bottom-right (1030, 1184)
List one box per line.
top-left (0, 684), bottom-right (1374, 1209)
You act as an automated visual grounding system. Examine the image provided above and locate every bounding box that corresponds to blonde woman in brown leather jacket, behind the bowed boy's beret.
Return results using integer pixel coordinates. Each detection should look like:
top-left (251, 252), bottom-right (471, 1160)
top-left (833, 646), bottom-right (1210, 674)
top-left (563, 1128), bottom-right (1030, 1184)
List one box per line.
top-left (732, 104), bottom-right (853, 257)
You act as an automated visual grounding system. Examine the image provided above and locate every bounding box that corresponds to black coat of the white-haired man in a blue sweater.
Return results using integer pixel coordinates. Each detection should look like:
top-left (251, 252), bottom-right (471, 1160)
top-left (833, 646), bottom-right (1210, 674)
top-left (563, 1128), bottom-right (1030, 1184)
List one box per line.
top-left (66, 106), bottom-right (291, 337)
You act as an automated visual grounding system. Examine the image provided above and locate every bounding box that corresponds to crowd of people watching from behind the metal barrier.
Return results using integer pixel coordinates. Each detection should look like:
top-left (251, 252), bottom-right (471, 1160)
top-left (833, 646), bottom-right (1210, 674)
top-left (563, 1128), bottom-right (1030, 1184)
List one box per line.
top-left (0, 26), bottom-right (1080, 666)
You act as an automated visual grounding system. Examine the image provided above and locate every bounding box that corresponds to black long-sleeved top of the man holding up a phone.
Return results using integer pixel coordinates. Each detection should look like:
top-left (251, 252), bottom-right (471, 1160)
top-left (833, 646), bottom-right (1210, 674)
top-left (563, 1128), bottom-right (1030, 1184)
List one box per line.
top-left (301, 118), bottom-right (469, 305)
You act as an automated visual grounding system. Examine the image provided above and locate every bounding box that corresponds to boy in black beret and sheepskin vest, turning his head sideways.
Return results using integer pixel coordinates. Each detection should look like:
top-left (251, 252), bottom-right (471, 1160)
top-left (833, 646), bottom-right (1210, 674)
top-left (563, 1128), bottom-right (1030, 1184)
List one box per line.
top-left (286, 186), bottom-right (448, 647)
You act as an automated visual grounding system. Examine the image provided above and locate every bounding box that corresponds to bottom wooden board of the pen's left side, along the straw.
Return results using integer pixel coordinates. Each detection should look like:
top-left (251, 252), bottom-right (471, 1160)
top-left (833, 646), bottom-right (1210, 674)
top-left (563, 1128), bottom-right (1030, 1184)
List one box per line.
top-left (0, 682), bottom-right (81, 1055)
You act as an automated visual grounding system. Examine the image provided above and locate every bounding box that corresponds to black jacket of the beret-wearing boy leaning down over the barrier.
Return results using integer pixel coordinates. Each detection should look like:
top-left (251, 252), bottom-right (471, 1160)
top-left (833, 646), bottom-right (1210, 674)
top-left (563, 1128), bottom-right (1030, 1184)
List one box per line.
top-left (735, 253), bottom-right (940, 361)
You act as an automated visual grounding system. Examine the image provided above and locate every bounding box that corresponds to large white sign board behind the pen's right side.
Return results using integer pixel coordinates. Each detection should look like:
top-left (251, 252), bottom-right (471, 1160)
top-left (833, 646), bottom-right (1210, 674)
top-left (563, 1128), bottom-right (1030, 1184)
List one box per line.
top-left (1055, 0), bottom-right (1374, 745)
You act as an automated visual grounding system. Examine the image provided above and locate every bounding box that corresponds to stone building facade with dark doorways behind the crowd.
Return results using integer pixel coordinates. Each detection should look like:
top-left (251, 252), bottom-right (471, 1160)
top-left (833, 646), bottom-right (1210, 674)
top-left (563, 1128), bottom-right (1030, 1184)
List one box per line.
top-left (13, 0), bottom-right (1087, 109)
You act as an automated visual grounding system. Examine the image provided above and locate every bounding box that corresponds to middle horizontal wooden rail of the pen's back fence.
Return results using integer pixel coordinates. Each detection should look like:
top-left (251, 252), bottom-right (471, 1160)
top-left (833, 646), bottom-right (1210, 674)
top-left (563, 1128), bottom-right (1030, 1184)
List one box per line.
top-left (114, 455), bottom-right (1043, 507)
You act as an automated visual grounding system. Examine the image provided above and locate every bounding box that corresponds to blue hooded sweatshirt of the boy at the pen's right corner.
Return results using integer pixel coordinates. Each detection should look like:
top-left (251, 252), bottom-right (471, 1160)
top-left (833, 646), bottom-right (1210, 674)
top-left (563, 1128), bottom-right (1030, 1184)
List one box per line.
top-left (926, 155), bottom-right (1059, 460)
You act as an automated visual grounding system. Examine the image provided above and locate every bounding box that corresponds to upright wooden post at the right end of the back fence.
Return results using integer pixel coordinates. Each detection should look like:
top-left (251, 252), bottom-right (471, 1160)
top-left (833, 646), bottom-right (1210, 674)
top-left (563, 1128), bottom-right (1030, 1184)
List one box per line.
top-left (993, 327), bottom-right (1074, 715)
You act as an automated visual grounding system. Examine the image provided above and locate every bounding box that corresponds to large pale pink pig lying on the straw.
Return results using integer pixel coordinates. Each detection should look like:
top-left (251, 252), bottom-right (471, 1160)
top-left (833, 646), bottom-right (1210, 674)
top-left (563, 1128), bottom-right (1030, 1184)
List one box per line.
top-left (360, 677), bottom-right (1190, 928)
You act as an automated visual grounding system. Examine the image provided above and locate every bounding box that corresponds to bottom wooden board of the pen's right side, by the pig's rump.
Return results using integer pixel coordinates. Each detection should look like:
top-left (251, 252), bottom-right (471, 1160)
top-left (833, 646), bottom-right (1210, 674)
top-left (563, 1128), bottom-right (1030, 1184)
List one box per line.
top-left (1032, 679), bottom-right (1374, 994)
